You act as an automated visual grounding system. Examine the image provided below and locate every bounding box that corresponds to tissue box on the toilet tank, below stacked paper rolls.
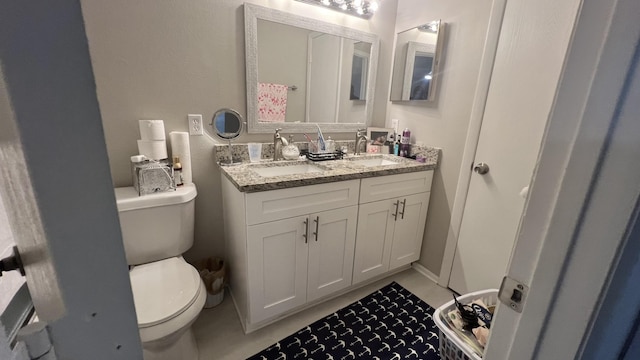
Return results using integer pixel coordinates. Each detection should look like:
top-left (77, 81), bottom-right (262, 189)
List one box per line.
top-left (131, 160), bottom-right (176, 196)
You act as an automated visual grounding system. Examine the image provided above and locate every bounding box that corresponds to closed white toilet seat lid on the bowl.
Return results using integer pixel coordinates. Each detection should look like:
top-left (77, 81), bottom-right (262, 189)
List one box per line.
top-left (129, 257), bottom-right (204, 329)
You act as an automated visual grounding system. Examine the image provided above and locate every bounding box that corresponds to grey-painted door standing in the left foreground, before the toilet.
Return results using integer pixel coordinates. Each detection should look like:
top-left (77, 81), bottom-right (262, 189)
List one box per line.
top-left (0, 1), bottom-right (142, 359)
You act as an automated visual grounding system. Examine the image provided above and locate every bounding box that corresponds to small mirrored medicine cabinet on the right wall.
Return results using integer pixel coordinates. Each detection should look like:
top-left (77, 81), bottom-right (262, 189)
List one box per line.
top-left (390, 20), bottom-right (444, 101)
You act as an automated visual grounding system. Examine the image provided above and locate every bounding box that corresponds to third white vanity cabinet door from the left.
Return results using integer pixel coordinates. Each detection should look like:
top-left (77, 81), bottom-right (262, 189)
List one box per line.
top-left (353, 200), bottom-right (397, 284)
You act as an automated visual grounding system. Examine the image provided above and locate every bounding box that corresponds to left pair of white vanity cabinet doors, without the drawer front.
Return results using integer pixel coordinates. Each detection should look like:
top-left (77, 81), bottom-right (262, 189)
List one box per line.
top-left (247, 205), bottom-right (358, 322)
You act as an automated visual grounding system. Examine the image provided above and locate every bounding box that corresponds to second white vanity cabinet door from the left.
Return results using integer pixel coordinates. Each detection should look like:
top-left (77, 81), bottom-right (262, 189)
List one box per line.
top-left (307, 206), bottom-right (358, 301)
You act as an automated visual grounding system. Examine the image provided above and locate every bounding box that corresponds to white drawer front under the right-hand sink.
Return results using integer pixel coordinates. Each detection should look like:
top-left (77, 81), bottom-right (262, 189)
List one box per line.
top-left (360, 170), bottom-right (433, 204)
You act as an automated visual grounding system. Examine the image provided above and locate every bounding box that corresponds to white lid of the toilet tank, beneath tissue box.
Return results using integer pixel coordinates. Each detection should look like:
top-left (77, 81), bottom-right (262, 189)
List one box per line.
top-left (115, 184), bottom-right (198, 211)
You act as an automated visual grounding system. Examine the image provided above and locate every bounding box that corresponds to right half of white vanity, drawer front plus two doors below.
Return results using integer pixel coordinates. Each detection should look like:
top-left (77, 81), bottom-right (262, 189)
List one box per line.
top-left (353, 171), bottom-right (433, 284)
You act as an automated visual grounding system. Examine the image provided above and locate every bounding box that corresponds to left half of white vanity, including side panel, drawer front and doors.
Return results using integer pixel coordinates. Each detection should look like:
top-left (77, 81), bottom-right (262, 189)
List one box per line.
top-left (222, 177), bottom-right (360, 331)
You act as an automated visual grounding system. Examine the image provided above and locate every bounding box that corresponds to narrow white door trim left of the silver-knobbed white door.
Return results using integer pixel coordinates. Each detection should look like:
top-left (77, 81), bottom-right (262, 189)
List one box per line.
top-left (436, 0), bottom-right (507, 287)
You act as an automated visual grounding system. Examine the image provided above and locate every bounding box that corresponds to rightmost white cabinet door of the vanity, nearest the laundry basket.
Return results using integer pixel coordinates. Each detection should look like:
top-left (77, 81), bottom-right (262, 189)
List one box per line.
top-left (389, 192), bottom-right (431, 270)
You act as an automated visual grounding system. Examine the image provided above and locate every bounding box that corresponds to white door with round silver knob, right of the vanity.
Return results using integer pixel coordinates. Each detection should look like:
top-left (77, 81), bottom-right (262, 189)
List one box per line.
top-left (448, 0), bottom-right (580, 293)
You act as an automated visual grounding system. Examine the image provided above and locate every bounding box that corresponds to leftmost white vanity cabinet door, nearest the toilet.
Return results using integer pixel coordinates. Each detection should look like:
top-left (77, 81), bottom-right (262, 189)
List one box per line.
top-left (247, 216), bottom-right (308, 323)
